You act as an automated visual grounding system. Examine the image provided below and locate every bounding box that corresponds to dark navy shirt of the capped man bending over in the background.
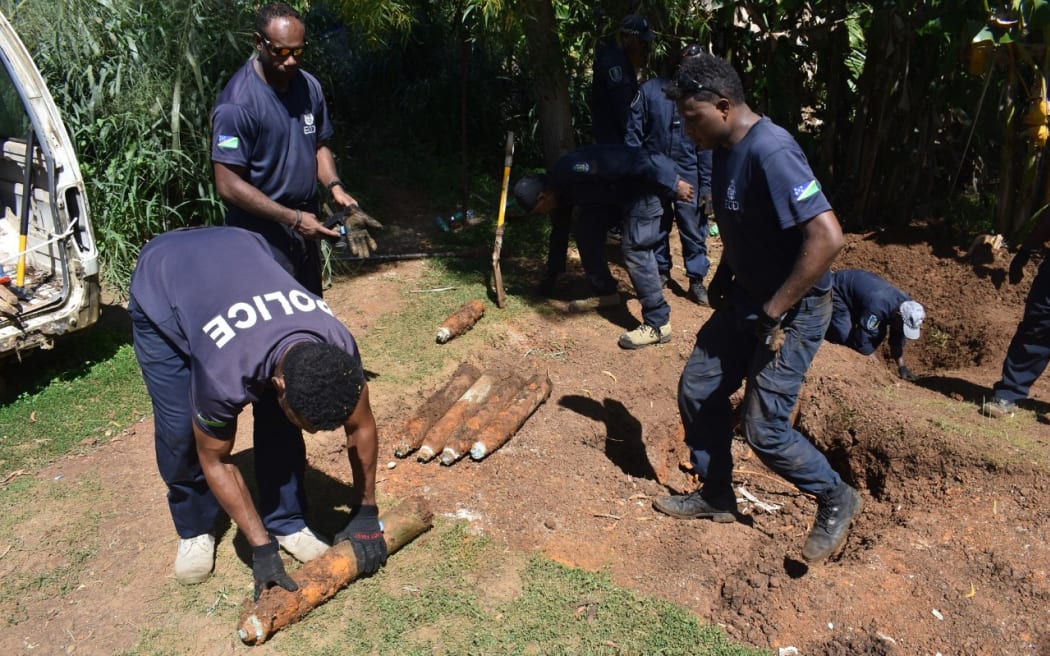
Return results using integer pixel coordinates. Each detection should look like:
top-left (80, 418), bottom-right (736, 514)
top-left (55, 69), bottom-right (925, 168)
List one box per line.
top-left (548, 144), bottom-right (678, 207)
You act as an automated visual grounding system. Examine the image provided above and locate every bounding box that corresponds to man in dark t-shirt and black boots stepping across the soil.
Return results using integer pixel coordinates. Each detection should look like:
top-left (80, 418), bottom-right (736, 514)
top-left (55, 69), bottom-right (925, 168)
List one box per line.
top-left (653, 54), bottom-right (862, 562)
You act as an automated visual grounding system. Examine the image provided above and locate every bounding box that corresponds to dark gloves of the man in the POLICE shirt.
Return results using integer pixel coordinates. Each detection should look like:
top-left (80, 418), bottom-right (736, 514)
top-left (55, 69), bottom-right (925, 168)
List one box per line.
top-left (252, 506), bottom-right (389, 601)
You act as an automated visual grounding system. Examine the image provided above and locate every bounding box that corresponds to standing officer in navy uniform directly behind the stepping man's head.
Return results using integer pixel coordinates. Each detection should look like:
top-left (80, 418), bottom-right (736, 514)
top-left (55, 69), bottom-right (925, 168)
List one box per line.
top-left (624, 44), bottom-right (711, 305)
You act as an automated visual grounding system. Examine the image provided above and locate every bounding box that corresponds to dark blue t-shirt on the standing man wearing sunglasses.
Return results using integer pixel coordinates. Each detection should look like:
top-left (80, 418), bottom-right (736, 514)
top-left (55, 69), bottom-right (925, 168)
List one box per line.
top-left (211, 58), bottom-right (333, 241)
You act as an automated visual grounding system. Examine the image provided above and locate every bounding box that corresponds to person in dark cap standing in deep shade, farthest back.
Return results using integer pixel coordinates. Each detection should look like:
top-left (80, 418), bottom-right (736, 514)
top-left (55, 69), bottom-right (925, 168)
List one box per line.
top-left (590, 14), bottom-right (656, 144)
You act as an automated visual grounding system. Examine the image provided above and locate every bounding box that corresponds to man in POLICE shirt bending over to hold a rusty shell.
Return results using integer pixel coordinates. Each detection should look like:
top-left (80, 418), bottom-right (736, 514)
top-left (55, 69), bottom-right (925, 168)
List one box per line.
top-left (128, 228), bottom-right (386, 599)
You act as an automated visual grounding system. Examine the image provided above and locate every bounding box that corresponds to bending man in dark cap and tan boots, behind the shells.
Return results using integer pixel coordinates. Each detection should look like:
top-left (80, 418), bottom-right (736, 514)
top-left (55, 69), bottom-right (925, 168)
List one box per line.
top-left (515, 144), bottom-right (695, 348)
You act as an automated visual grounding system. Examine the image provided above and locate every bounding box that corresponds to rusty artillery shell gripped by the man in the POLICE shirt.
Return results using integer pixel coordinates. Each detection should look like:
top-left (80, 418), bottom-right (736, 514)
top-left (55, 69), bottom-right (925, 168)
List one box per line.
top-left (237, 499), bottom-right (434, 644)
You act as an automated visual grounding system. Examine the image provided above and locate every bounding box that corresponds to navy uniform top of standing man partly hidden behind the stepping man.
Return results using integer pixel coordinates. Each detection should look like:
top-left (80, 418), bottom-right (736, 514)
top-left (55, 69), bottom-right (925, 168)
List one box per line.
top-left (624, 78), bottom-right (711, 199)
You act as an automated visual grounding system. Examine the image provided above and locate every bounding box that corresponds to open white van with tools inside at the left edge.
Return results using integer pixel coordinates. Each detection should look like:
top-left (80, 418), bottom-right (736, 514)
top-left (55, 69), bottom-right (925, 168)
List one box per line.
top-left (0, 14), bottom-right (100, 366)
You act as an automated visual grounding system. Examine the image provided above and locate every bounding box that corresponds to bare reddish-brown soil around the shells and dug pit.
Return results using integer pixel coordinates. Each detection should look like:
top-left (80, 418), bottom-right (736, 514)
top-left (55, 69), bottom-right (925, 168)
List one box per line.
top-left (0, 204), bottom-right (1050, 656)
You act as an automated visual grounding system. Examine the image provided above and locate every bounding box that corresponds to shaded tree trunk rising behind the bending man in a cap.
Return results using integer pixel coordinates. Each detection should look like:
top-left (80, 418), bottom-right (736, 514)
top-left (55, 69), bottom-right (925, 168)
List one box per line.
top-left (518, 0), bottom-right (575, 168)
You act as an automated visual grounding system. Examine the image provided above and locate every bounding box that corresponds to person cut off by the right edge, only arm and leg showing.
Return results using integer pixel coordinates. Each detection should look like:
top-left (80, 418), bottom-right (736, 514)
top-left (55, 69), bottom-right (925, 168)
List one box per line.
top-left (981, 209), bottom-right (1050, 419)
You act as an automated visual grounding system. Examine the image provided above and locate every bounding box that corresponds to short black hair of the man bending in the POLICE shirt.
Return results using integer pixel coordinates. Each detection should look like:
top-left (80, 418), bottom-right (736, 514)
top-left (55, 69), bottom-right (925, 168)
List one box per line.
top-left (281, 342), bottom-right (364, 430)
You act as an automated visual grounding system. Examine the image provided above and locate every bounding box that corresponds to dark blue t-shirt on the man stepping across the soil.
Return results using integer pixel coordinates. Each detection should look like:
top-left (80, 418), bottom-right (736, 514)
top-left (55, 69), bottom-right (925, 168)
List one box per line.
top-left (711, 117), bottom-right (832, 306)
